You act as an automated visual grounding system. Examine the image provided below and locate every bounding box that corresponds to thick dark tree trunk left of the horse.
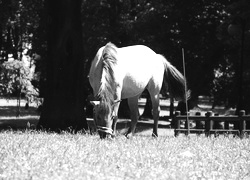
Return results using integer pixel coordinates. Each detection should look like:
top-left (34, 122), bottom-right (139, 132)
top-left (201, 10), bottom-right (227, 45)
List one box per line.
top-left (38, 0), bottom-right (88, 131)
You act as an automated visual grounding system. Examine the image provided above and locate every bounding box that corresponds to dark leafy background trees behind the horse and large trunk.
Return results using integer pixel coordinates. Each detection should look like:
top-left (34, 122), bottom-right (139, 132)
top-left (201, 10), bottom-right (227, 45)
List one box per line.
top-left (0, 0), bottom-right (250, 125)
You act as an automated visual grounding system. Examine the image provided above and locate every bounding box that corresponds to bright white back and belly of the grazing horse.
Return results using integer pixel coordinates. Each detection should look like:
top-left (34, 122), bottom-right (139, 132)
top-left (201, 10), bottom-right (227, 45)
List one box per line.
top-left (117, 45), bottom-right (164, 98)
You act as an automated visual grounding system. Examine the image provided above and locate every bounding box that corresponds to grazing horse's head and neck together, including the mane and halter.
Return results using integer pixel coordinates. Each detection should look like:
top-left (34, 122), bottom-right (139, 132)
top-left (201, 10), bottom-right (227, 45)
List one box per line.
top-left (89, 43), bottom-right (118, 138)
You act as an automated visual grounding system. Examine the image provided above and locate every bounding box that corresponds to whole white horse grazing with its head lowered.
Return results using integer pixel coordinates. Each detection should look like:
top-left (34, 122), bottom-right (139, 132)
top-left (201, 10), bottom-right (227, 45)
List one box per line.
top-left (89, 43), bottom-right (187, 138)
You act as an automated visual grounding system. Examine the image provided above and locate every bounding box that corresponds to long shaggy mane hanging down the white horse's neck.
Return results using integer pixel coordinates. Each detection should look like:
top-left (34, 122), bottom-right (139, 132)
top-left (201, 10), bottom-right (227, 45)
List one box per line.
top-left (98, 43), bottom-right (117, 114)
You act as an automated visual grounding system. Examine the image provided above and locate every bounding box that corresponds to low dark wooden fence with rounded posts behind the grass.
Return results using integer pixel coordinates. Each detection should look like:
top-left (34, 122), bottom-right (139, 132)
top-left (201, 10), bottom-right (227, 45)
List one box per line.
top-left (173, 110), bottom-right (250, 137)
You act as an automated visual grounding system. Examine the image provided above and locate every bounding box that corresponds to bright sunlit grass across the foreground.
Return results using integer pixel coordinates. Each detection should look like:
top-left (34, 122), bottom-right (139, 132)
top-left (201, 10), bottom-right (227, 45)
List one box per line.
top-left (0, 131), bottom-right (250, 179)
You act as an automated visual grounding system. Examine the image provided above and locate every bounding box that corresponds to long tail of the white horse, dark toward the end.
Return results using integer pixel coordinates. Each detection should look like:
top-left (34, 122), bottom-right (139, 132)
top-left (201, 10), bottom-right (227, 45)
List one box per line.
top-left (159, 54), bottom-right (190, 101)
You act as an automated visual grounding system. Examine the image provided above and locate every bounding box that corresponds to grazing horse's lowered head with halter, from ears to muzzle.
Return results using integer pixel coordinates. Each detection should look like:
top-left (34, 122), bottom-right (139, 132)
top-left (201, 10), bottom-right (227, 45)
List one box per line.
top-left (90, 100), bottom-right (120, 138)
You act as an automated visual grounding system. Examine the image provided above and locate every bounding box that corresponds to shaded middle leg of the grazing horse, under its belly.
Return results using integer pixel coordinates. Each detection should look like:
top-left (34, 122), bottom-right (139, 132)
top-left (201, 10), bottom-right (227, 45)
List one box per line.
top-left (126, 96), bottom-right (139, 136)
